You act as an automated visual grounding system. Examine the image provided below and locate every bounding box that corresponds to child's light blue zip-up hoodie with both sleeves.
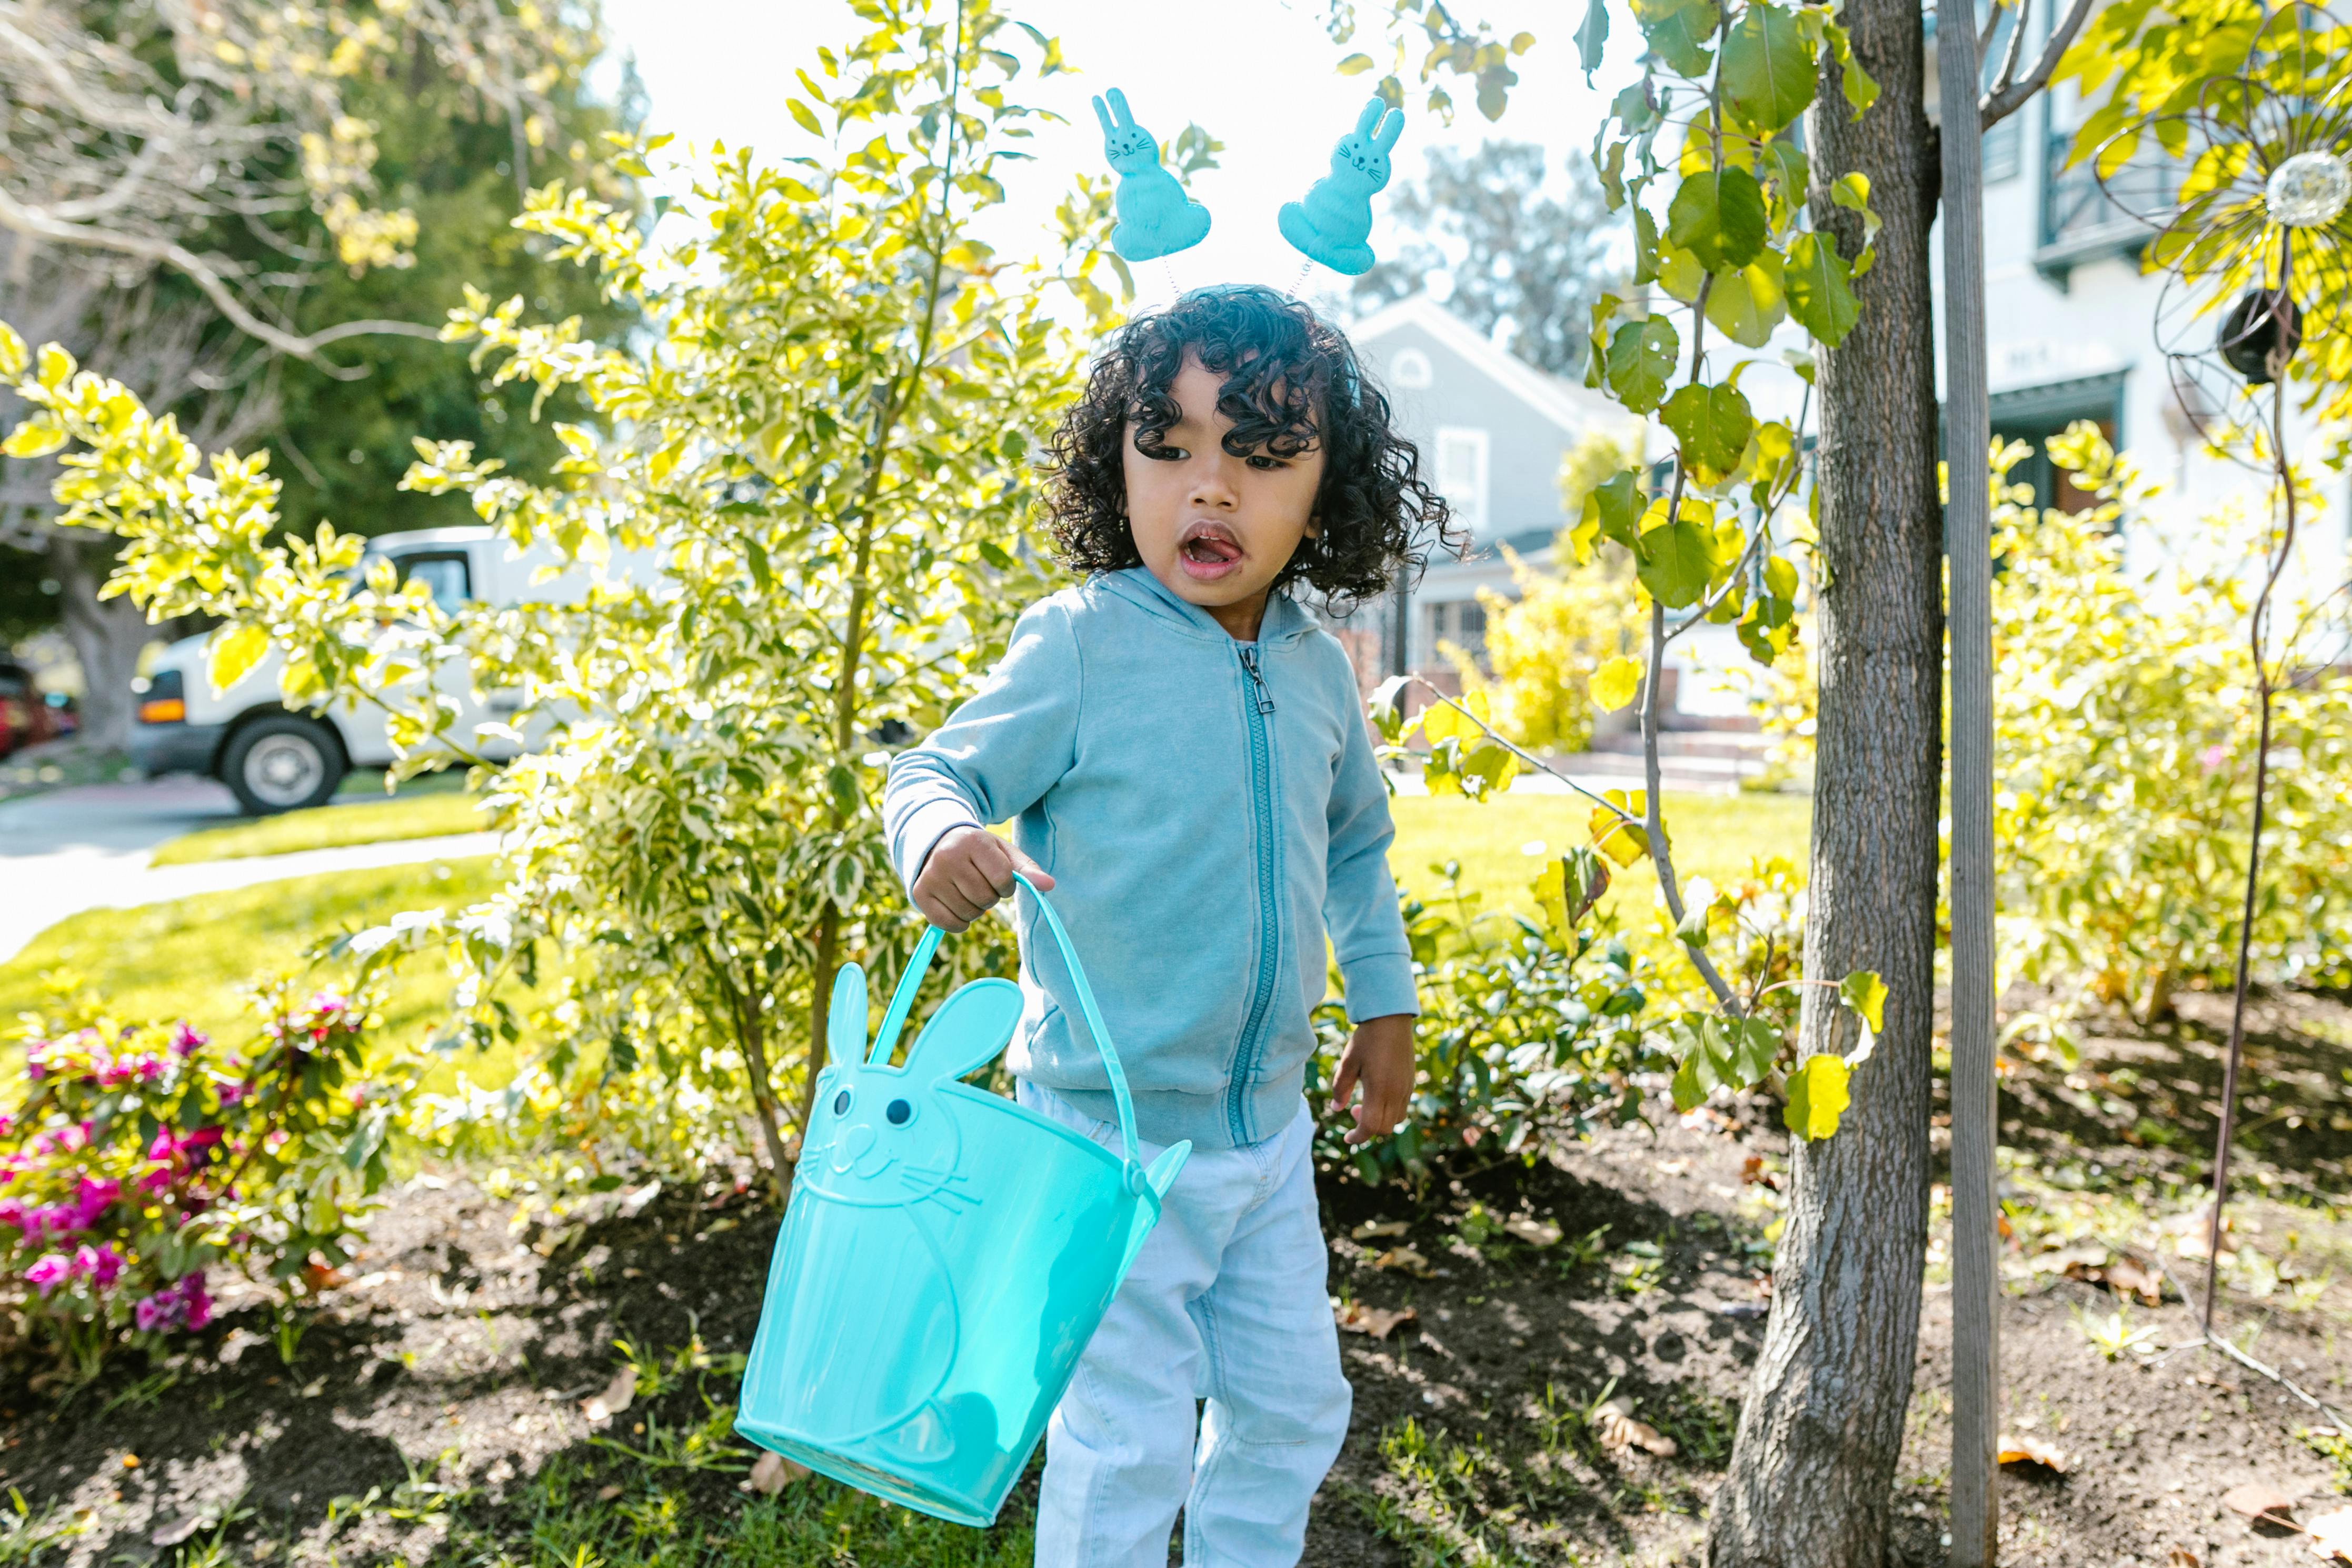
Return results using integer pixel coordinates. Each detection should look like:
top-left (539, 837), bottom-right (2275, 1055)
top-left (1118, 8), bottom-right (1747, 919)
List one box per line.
top-left (882, 566), bottom-right (1421, 1147)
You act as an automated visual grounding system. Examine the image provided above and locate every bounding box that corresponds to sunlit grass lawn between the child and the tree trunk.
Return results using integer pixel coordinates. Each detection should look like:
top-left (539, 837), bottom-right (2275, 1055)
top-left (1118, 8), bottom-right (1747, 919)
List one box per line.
top-left (1388, 795), bottom-right (1813, 914)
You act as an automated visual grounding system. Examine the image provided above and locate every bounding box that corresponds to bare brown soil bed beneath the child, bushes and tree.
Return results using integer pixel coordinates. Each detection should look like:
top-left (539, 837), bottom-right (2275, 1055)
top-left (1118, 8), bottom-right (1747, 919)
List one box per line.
top-left (0, 997), bottom-right (2352, 1568)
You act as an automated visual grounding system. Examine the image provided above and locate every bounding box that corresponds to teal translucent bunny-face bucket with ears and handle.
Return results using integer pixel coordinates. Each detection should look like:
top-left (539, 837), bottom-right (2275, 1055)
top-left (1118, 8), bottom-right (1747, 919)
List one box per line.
top-left (736, 877), bottom-right (1192, 1526)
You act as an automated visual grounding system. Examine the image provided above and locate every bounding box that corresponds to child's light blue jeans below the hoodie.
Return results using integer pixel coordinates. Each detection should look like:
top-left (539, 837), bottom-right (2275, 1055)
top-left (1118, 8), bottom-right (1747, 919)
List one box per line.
top-left (1019, 1081), bottom-right (1352, 1568)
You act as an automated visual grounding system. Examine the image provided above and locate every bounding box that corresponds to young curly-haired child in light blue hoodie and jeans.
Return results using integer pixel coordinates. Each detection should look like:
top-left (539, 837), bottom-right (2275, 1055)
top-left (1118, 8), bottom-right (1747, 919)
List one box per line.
top-left (884, 287), bottom-right (1447, 1568)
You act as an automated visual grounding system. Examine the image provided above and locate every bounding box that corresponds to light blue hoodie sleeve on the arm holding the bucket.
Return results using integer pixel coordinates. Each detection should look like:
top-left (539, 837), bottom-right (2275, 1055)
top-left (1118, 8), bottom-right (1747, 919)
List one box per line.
top-left (882, 600), bottom-right (1080, 888)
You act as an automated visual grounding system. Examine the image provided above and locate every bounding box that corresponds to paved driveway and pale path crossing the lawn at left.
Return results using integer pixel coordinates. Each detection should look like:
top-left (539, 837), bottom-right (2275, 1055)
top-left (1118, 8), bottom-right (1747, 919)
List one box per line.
top-left (0, 778), bottom-right (499, 964)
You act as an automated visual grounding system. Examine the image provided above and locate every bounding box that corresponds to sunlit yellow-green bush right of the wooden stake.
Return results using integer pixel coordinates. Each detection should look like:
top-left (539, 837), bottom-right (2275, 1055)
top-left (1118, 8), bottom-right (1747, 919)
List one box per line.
top-left (1992, 425), bottom-right (2352, 1018)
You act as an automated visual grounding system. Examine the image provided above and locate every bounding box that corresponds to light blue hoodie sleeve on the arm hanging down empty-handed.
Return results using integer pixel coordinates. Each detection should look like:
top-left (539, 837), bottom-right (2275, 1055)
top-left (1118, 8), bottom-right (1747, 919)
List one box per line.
top-left (1324, 656), bottom-right (1421, 1023)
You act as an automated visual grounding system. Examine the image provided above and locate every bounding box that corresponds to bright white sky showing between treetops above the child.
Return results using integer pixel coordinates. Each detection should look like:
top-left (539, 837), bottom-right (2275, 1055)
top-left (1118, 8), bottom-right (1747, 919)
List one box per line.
top-left (583, 0), bottom-right (1632, 303)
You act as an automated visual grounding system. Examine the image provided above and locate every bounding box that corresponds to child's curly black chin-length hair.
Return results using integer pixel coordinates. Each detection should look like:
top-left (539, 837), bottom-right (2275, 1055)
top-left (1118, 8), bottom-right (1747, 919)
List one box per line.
top-left (1047, 284), bottom-right (1461, 609)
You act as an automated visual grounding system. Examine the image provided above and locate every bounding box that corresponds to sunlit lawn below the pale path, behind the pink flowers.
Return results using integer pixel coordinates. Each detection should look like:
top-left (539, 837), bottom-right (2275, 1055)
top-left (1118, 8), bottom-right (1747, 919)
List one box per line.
top-left (0, 856), bottom-right (508, 1088)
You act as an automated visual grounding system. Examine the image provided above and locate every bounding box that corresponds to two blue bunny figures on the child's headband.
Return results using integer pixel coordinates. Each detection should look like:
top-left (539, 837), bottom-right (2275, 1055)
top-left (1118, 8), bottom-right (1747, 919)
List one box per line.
top-left (1094, 87), bottom-right (1404, 277)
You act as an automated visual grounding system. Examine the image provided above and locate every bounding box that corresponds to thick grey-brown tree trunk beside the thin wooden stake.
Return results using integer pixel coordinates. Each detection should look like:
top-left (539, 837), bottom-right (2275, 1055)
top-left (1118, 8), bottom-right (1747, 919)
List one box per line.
top-left (1708, 0), bottom-right (1943, 1568)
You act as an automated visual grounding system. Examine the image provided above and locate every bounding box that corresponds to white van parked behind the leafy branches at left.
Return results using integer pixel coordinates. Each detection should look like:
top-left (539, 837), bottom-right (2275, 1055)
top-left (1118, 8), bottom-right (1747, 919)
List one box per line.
top-left (132, 526), bottom-right (659, 816)
